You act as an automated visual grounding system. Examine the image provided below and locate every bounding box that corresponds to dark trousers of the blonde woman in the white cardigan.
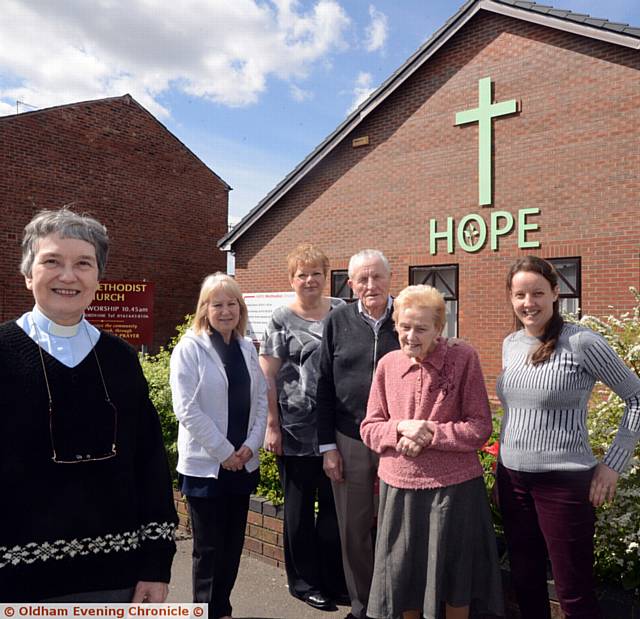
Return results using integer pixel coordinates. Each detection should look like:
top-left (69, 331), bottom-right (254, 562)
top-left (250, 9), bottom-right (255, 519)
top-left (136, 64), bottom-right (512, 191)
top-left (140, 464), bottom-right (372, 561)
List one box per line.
top-left (187, 494), bottom-right (249, 619)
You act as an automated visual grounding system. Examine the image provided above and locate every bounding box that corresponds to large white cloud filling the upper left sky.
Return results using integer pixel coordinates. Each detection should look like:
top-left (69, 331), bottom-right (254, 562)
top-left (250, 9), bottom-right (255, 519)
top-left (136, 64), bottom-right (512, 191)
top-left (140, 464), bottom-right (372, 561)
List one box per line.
top-left (0, 0), bottom-right (350, 117)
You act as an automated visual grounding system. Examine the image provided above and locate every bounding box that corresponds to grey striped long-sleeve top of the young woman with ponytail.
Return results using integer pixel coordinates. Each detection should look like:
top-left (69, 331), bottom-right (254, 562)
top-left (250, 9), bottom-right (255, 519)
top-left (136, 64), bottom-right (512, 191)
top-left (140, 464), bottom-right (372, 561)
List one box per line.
top-left (497, 324), bottom-right (640, 472)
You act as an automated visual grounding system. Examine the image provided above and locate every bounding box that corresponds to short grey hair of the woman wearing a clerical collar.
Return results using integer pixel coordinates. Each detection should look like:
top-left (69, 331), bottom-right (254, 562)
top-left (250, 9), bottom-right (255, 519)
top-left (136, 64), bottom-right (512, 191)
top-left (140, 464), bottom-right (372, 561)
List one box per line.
top-left (20, 207), bottom-right (109, 279)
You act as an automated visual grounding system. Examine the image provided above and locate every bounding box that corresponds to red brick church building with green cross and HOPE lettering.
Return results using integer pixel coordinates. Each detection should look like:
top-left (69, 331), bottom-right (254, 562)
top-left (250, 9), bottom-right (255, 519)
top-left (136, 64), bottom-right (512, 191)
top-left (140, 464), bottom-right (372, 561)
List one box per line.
top-left (219, 0), bottom-right (640, 384)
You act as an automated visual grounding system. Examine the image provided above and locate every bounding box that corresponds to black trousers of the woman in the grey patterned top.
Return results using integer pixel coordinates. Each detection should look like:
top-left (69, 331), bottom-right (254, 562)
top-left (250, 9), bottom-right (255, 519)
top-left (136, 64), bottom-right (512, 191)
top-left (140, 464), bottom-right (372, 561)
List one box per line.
top-left (278, 456), bottom-right (346, 598)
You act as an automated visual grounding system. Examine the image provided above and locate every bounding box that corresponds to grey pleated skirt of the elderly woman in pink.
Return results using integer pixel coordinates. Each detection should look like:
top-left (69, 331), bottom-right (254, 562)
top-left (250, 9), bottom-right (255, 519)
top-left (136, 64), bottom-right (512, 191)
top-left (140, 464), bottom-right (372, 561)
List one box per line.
top-left (367, 477), bottom-right (504, 619)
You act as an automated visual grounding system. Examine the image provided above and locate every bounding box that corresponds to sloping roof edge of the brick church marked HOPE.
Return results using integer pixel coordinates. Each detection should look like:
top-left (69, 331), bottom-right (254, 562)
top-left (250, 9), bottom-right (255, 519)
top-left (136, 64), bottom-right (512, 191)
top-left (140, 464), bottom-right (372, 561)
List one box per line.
top-left (218, 0), bottom-right (640, 251)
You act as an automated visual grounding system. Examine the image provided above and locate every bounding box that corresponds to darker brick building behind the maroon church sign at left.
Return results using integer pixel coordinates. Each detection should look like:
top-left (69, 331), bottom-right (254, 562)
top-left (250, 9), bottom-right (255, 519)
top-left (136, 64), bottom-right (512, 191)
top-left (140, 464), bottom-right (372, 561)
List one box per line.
top-left (0, 95), bottom-right (230, 348)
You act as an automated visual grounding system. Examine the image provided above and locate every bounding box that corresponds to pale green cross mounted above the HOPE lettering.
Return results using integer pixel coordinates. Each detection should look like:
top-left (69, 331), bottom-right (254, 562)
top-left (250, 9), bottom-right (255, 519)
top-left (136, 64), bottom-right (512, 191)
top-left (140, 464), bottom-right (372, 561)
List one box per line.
top-left (455, 77), bottom-right (518, 206)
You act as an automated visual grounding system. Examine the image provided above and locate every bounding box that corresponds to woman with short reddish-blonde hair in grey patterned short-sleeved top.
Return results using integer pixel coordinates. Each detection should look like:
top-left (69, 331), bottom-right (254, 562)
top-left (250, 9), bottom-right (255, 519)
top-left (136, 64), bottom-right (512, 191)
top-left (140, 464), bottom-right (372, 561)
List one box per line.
top-left (260, 243), bottom-right (345, 610)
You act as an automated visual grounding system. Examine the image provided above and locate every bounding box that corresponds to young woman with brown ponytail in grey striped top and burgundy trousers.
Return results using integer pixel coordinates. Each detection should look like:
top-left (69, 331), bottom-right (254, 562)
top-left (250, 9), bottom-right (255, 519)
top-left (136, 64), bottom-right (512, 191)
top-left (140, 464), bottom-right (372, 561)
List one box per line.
top-left (497, 256), bottom-right (640, 619)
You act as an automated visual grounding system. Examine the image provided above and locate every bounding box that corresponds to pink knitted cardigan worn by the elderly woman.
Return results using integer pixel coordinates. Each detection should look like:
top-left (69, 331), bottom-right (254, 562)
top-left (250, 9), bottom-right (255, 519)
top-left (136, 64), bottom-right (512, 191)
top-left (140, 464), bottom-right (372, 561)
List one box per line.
top-left (360, 338), bottom-right (491, 489)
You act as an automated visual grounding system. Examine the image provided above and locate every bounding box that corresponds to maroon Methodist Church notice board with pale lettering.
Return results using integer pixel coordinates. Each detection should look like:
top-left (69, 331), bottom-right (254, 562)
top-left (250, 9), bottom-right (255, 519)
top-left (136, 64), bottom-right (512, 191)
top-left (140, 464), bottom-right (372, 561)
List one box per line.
top-left (84, 280), bottom-right (154, 346)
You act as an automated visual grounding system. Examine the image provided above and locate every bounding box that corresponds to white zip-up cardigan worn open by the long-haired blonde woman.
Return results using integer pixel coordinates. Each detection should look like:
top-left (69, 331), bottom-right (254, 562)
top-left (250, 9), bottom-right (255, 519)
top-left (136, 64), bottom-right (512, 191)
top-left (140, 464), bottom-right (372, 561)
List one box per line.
top-left (170, 329), bottom-right (267, 478)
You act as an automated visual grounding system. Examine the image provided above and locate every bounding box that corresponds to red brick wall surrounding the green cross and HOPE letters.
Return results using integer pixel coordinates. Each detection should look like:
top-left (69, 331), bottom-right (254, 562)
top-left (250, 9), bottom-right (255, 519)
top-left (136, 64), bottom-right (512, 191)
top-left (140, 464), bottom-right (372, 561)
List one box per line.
top-left (234, 12), bottom-right (640, 386)
